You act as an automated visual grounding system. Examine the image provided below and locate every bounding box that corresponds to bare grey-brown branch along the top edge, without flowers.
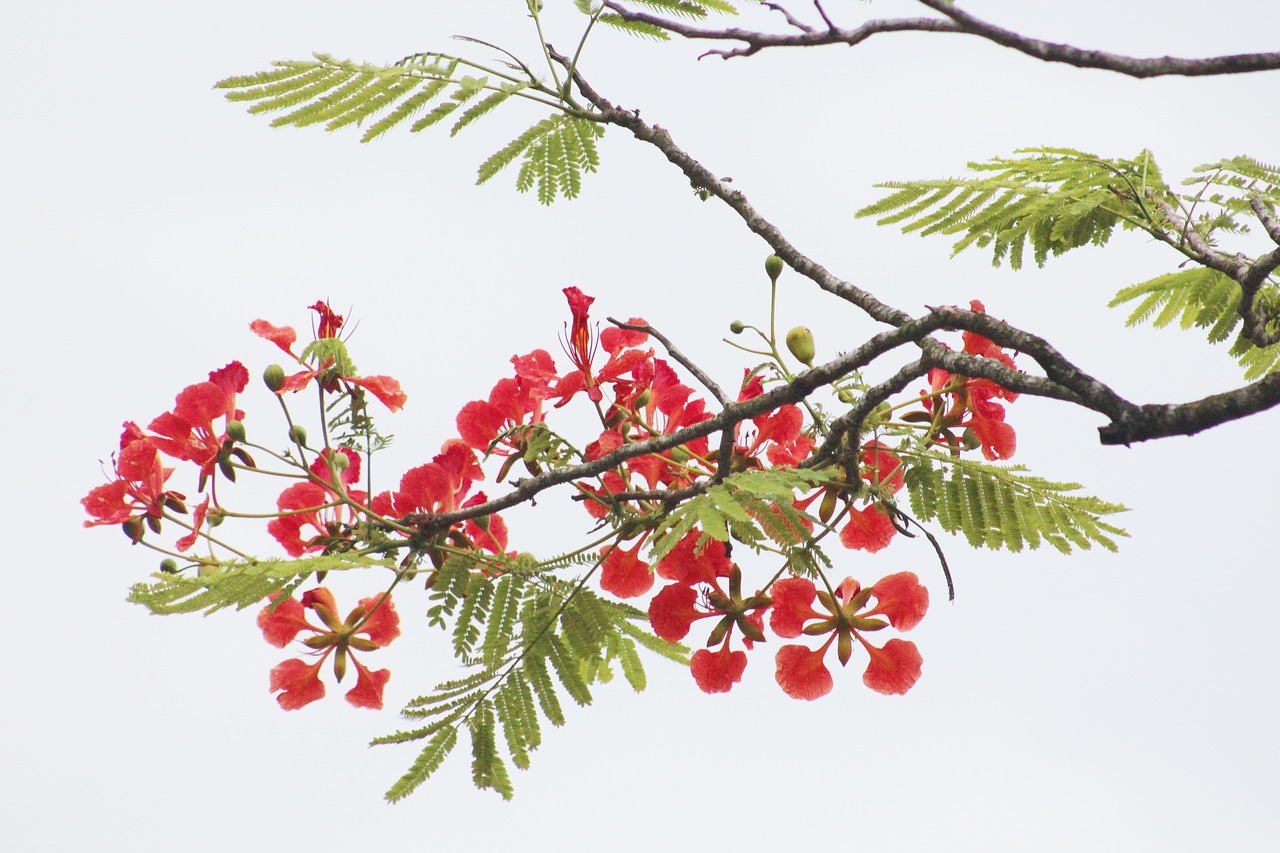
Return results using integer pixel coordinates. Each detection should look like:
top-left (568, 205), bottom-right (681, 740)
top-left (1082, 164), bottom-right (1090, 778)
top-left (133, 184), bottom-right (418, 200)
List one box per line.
top-left (604, 0), bottom-right (1280, 78)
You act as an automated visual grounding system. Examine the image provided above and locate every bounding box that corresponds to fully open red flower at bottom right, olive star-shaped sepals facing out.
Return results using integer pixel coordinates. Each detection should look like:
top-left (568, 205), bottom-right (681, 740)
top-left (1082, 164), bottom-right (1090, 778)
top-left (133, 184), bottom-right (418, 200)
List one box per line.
top-left (769, 571), bottom-right (929, 699)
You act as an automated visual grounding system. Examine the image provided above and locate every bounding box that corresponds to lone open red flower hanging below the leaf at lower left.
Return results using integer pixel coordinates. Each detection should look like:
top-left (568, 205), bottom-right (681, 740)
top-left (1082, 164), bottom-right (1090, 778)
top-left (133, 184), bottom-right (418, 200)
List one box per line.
top-left (257, 587), bottom-right (399, 711)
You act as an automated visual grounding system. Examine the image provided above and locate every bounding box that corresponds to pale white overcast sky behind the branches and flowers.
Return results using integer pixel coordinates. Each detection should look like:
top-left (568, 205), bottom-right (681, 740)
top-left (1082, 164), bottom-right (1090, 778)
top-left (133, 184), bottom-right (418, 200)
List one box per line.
top-left (0, 0), bottom-right (1280, 852)
